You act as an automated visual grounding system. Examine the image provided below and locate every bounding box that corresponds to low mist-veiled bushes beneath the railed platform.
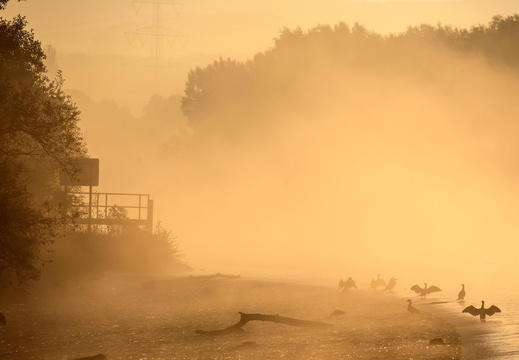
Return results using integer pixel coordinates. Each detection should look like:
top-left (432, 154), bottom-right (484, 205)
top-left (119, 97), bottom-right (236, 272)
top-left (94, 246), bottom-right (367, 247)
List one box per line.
top-left (43, 223), bottom-right (191, 283)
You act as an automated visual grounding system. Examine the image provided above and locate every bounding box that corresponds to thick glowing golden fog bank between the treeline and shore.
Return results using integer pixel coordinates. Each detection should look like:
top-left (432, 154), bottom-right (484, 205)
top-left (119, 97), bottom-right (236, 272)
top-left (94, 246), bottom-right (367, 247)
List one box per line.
top-left (64, 31), bottom-right (519, 296)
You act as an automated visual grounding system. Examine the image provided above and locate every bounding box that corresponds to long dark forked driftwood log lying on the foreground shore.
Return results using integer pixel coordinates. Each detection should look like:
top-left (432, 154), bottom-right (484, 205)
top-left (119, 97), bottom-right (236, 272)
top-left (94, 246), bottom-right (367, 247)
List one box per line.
top-left (195, 312), bottom-right (333, 335)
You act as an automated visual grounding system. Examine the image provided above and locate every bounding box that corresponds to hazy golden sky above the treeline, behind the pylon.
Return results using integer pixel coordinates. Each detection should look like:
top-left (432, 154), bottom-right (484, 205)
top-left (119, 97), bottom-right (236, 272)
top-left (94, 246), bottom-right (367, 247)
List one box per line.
top-left (2, 0), bottom-right (519, 107)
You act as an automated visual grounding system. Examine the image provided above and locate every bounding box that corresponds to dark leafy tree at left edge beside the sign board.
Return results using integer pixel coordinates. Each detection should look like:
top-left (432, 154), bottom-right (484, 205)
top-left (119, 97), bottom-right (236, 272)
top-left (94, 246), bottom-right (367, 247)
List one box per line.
top-left (0, 14), bottom-right (86, 286)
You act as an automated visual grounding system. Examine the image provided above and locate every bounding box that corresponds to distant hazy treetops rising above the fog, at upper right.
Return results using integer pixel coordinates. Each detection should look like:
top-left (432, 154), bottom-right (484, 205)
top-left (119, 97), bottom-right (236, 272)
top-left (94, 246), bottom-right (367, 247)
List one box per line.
top-left (182, 14), bottom-right (519, 132)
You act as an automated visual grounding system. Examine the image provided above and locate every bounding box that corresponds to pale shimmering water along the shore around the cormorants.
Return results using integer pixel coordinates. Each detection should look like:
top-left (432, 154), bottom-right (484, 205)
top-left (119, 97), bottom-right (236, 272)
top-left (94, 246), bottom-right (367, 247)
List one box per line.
top-left (198, 268), bottom-right (519, 360)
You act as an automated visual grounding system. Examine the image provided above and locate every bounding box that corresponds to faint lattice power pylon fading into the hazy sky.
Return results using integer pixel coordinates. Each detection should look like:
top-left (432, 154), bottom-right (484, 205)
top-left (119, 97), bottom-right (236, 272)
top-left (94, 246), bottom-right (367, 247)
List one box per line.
top-left (126, 0), bottom-right (187, 88)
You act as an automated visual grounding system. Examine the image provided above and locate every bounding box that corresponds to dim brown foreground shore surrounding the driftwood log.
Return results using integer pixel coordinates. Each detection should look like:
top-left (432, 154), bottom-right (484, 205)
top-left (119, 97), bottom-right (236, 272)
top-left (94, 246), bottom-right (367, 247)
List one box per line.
top-left (0, 275), bottom-right (496, 360)
